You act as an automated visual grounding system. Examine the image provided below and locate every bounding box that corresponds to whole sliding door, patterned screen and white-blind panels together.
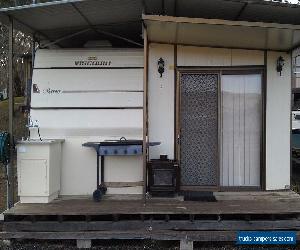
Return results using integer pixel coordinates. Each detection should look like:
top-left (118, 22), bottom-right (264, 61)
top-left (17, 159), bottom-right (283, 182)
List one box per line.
top-left (177, 69), bottom-right (263, 190)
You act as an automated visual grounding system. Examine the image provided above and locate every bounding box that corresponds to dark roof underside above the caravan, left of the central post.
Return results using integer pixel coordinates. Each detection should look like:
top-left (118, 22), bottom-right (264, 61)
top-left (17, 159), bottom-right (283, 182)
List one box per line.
top-left (0, 0), bottom-right (143, 47)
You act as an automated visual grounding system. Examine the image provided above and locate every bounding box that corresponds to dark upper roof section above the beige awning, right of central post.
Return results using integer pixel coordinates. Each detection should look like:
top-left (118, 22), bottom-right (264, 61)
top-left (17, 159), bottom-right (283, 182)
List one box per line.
top-left (145, 0), bottom-right (300, 24)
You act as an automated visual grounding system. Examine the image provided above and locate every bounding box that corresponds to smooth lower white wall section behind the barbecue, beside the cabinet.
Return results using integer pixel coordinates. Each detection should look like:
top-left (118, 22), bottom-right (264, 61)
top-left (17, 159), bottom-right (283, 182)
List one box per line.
top-left (60, 136), bottom-right (143, 195)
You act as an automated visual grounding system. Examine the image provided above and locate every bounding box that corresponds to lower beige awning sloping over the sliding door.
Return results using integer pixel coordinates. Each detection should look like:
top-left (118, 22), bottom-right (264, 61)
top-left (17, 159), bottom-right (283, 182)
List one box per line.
top-left (143, 15), bottom-right (300, 51)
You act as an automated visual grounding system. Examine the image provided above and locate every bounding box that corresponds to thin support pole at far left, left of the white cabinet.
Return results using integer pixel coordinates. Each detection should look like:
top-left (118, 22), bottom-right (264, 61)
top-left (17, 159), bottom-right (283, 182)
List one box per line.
top-left (6, 17), bottom-right (14, 208)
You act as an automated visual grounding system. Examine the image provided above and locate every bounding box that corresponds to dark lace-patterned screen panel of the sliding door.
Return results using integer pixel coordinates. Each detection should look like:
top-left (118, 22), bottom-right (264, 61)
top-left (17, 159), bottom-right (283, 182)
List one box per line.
top-left (180, 73), bottom-right (219, 186)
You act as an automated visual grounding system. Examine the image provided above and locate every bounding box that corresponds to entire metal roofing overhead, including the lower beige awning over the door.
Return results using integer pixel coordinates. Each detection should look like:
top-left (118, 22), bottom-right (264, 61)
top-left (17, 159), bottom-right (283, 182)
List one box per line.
top-left (0, 0), bottom-right (300, 50)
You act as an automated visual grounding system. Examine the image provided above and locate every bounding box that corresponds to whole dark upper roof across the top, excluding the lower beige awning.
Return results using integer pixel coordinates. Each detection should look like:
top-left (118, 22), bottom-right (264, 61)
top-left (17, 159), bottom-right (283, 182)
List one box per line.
top-left (0, 0), bottom-right (300, 47)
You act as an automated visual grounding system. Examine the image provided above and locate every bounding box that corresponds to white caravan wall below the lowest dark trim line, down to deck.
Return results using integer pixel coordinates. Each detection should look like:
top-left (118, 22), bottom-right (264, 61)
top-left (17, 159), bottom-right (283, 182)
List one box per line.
top-left (31, 109), bottom-right (143, 195)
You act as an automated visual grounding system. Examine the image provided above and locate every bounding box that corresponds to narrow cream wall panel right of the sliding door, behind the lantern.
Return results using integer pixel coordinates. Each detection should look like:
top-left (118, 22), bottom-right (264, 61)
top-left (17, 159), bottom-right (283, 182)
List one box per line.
top-left (266, 51), bottom-right (291, 190)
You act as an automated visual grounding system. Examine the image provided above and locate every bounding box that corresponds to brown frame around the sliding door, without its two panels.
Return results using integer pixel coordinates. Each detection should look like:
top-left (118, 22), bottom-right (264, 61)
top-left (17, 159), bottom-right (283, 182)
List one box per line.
top-left (174, 65), bottom-right (266, 191)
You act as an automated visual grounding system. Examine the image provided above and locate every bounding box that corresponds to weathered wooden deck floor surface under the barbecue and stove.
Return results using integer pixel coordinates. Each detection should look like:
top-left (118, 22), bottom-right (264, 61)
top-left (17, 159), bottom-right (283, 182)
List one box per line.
top-left (4, 192), bottom-right (300, 216)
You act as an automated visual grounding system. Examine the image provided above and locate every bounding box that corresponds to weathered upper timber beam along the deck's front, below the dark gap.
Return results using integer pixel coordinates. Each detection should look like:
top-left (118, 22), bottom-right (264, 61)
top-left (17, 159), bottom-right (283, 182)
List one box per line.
top-left (3, 219), bottom-right (300, 232)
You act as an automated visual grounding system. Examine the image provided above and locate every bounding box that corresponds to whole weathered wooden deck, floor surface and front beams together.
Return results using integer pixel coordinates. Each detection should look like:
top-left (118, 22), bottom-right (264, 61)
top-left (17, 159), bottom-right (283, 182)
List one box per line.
top-left (0, 191), bottom-right (300, 241)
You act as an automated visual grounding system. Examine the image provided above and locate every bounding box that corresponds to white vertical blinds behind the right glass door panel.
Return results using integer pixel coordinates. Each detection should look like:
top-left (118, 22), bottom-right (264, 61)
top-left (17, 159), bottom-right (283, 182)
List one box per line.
top-left (220, 74), bottom-right (262, 186)
